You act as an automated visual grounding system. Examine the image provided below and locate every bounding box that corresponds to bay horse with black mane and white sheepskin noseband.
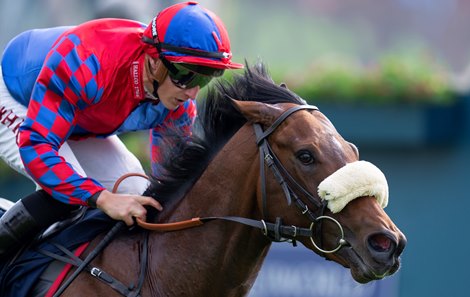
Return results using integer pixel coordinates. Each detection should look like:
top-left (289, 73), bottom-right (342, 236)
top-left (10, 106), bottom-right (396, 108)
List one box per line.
top-left (6, 64), bottom-right (406, 296)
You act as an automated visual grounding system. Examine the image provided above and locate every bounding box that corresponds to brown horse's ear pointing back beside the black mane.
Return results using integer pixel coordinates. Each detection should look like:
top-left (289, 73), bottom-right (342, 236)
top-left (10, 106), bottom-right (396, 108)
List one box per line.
top-left (232, 99), bottom-right (282, 126)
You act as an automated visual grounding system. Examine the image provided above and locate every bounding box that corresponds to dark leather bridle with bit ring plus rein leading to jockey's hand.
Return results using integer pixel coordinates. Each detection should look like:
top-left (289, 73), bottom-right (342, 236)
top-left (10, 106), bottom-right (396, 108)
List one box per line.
top-left (134, 105), bottom-right (347, 254)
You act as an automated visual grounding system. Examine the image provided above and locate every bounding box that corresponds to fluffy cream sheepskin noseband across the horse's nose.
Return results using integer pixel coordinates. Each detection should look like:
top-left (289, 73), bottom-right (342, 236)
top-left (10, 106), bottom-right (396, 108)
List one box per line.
top-left (318, 161), bottom-right (388, 213)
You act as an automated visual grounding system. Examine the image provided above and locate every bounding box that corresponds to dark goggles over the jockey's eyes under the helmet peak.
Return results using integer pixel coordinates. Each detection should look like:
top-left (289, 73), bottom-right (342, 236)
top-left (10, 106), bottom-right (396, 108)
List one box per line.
top-left (168, 63), bottom-right (224, 89)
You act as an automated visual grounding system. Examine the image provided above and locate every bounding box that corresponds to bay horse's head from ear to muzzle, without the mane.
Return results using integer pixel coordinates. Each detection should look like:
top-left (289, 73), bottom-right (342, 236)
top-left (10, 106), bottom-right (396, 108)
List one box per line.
top-left (234, 101), bottom-right (406, 283)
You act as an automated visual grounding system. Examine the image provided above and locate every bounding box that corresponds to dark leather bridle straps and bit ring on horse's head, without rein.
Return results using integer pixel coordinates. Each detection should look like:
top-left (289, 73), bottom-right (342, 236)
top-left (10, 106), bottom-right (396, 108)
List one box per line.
top-left (253, 105), bottom-right (347, 254)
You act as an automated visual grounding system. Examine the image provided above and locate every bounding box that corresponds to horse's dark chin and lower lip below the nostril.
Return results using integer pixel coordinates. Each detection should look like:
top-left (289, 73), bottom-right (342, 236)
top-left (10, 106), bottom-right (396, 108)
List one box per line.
top-left (338, 247), bottom-right (400, 284)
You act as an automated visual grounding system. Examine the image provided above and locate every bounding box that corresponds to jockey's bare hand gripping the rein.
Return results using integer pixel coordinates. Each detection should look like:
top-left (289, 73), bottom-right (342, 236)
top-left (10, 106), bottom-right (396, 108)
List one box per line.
top-left (96, 190), bottom-right (163, 226)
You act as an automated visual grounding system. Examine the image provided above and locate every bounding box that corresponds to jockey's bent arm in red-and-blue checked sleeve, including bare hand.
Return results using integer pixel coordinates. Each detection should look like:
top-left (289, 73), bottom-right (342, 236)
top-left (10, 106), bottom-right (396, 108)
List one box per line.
top-left (19, 34), bottom-right (161, 225)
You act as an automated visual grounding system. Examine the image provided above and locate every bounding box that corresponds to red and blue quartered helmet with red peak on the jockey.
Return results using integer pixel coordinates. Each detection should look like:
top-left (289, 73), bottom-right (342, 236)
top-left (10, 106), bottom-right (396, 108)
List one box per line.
top-left (143, 1), bottom-right (243, 69)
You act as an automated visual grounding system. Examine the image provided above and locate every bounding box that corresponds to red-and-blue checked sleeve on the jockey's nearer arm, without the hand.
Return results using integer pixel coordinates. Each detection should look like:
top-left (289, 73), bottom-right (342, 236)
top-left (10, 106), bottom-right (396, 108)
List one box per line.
top-left (19, 34), bottom-right (104, 205)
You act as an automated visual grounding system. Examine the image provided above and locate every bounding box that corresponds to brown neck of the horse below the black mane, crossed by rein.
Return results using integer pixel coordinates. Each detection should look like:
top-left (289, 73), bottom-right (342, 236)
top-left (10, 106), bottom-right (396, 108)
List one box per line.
top-left (150, 127), bottom-right (270, 296)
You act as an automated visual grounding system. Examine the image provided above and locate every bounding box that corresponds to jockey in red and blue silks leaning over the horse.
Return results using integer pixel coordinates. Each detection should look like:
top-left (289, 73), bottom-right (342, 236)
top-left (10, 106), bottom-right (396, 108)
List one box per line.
top-left (0, 2), bottom-right (243, 257)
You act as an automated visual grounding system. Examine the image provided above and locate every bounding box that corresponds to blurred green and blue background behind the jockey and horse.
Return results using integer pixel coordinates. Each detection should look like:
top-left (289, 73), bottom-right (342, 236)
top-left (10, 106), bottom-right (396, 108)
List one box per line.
top-left (0, 0), bottom-right (470, 297)
